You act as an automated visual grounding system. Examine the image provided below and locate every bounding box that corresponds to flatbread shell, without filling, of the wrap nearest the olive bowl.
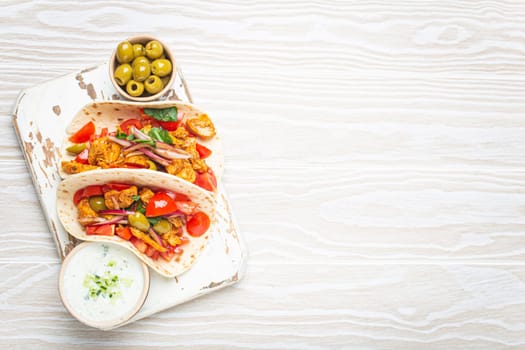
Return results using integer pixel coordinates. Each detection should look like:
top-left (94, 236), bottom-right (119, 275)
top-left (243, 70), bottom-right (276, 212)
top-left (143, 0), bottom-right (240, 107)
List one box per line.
top-left (59, 101), bottom-right (224, 194)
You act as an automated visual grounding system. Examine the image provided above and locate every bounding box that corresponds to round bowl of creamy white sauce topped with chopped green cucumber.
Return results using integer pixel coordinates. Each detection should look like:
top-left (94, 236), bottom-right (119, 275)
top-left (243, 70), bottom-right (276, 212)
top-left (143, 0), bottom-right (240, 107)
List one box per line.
top-left (59, 242), bottom-right (149, 330)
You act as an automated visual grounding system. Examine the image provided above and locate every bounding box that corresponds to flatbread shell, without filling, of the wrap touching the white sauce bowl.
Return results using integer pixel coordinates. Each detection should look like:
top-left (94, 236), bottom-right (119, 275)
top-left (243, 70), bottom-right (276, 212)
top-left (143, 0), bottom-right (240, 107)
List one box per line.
top-left (57, 169), bottom-right (216, 277)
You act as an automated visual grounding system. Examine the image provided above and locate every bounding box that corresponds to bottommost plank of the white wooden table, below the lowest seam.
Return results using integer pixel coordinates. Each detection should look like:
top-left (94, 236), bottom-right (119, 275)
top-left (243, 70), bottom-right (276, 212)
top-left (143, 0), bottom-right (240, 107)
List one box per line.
top-left (0, 263), bottom-right (525, 349)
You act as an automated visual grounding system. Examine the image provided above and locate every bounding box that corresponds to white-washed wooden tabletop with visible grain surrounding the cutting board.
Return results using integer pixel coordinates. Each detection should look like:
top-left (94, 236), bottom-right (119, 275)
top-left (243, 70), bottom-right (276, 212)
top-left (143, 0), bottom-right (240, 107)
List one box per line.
top-left (0, 0), bottom-right (525, 350)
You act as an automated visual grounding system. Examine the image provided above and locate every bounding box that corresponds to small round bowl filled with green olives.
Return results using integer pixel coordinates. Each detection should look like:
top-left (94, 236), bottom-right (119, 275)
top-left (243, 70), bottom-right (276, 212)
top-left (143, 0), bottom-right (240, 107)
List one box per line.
top-left (109, 35), bottom-right (176, 102)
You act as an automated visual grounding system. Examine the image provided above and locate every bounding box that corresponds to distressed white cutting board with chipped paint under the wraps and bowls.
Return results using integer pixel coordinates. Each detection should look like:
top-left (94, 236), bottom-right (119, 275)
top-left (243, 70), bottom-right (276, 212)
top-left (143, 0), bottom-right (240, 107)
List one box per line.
top-left (13, 64), bottom-right (247, 322)
